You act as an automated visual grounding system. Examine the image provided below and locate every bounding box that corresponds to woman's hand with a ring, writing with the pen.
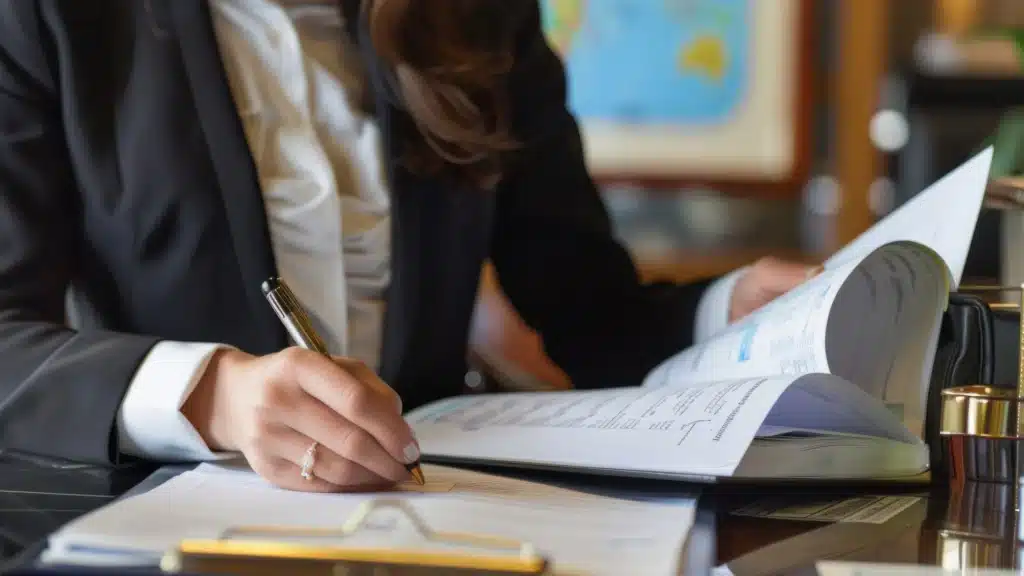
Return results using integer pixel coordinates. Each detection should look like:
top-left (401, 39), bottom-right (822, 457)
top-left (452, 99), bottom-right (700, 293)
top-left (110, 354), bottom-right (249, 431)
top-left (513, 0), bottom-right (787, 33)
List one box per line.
top-left (182, 342), bottom-right (419, 492)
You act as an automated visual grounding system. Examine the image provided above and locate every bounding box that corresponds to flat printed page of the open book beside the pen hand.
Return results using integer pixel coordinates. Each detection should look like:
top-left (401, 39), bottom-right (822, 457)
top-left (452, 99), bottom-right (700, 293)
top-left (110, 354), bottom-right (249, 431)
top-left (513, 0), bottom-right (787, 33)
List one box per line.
top-left (407, 377), bottom-right (806, 477)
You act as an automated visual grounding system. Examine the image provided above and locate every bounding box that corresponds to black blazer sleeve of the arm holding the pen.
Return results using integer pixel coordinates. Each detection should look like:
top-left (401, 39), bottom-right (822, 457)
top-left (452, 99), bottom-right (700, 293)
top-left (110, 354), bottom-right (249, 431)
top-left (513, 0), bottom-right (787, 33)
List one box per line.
top-left (0, 0), bottom-right (156, 464)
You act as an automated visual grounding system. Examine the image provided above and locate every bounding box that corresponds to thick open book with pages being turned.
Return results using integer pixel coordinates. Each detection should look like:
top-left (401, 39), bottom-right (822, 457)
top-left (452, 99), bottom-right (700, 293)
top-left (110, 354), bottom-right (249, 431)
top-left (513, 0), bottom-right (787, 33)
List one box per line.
top-left (407, 149), bottom-right (992, 482)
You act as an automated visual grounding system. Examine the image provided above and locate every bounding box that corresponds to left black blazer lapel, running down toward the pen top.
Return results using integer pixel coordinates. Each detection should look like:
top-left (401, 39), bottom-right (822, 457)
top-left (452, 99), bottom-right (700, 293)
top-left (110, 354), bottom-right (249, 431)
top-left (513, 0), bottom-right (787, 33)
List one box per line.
top-left (166, 0), bottom-right (288, 354)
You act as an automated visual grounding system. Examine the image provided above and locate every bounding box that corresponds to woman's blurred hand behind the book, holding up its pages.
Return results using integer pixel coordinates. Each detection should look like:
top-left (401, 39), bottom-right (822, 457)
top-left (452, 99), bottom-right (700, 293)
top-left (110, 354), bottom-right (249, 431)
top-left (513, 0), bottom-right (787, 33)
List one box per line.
top-left (729, 258), bottom-right (821, 323)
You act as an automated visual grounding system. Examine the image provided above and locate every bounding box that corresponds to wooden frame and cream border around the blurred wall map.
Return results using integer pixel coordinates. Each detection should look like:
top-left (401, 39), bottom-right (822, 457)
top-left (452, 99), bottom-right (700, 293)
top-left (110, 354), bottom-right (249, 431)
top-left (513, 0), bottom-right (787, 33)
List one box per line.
top-left (548, 0), bottom-right (815, 198)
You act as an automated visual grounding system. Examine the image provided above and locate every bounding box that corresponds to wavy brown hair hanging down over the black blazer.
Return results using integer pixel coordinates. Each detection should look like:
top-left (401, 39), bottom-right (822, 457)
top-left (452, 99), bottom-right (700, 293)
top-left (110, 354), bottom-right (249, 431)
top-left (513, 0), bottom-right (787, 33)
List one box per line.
top-left (365, 0), bottom-right (525, 189)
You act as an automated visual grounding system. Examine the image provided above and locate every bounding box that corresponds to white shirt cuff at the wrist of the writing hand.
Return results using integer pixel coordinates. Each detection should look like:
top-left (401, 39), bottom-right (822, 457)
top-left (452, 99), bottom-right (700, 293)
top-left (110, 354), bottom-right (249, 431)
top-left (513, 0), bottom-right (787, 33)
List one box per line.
top-left (117, 341), bottom-right (233, 462)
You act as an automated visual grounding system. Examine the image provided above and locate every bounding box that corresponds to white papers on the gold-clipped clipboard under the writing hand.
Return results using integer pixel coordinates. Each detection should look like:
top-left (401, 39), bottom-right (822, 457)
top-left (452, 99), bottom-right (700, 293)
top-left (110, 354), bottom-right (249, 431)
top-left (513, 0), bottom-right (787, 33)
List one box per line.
top-left (44, 464), bottom-right (695, 576)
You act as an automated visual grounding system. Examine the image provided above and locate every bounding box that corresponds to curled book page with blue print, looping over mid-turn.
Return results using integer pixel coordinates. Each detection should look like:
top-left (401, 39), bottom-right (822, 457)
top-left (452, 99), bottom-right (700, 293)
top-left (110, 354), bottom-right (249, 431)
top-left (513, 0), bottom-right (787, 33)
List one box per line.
top-left (643, 237), bottom-right (947, 437)
